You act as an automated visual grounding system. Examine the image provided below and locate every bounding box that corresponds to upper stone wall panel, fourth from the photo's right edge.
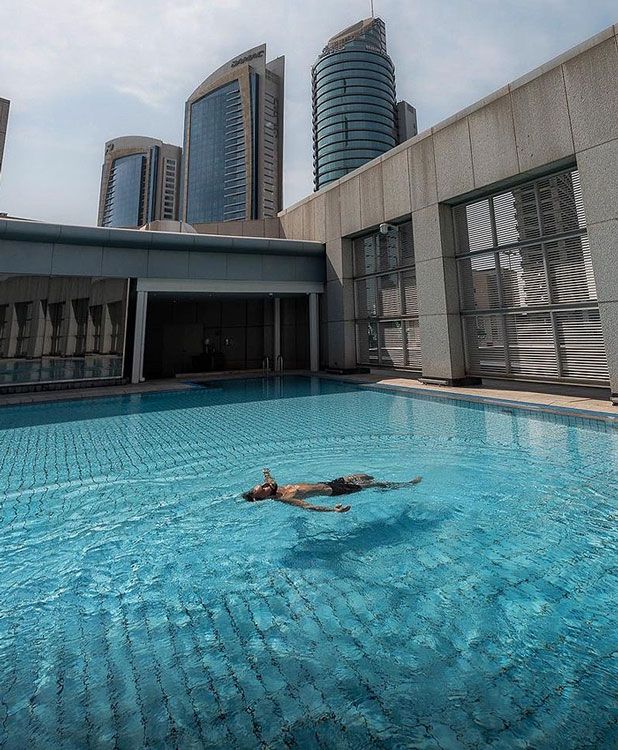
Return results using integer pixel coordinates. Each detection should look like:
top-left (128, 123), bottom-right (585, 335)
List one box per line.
top-left (433, 118), bottom-right (474, 201)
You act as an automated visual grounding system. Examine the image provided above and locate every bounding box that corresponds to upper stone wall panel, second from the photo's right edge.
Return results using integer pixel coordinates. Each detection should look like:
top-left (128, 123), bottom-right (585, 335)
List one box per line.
top-left (511, 68), bottom-right (575, 172)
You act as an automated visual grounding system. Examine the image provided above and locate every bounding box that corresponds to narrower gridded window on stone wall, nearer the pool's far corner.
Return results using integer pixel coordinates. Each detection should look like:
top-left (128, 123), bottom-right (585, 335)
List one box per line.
top-left (353, 222), bottom-right (422, 370)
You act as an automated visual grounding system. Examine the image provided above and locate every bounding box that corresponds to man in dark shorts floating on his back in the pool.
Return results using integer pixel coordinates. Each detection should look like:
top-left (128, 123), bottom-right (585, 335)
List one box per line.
top-left (243, 469), bottom-right (421, 513)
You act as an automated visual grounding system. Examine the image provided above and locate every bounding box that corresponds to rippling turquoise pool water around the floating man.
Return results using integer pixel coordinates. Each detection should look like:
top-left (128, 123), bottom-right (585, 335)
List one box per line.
top-left (0, 377), bottom-right (618, 750)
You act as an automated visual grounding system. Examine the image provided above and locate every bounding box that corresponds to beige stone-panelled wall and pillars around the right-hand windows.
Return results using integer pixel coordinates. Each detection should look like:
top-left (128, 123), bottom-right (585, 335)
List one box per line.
top-left (279, 22), bottom-right (618, 400)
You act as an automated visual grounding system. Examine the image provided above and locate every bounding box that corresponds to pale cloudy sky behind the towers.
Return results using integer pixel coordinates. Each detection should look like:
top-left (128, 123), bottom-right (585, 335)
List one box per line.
top-left (0, 0), bottom-right (618, 224)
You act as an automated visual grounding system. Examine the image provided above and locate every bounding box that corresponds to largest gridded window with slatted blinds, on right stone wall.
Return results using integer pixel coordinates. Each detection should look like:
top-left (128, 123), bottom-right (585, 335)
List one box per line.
top-left (454, 170), bottom-right (609, 385)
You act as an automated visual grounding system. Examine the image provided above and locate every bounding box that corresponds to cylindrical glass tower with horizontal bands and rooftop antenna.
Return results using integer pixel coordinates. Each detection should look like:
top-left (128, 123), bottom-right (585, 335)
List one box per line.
top-left (311, 18), bottom-right (416, 190)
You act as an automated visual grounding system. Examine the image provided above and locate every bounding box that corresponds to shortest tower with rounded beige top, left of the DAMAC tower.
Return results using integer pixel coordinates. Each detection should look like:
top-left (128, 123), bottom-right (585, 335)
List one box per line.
top-left (97, 135), bottom-right (182, 227)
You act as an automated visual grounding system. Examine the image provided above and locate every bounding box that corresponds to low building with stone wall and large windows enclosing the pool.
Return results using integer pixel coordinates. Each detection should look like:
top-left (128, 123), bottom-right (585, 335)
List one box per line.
top-left (0, 27), bottom-right (618, 403)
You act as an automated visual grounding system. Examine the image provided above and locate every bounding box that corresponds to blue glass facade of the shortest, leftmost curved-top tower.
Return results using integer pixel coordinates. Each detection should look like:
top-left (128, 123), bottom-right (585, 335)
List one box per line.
top-left (102, 154), bottom-right (146, 227)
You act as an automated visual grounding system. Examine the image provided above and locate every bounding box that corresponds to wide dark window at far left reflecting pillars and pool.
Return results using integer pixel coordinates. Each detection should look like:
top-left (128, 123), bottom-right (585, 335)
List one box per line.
top-left (0, 276), bottom-right (128, 386)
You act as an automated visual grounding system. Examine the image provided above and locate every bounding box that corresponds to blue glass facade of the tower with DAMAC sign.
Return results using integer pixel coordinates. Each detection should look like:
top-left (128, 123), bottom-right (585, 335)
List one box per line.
top-left (186, 80), bottom-right (251, 224)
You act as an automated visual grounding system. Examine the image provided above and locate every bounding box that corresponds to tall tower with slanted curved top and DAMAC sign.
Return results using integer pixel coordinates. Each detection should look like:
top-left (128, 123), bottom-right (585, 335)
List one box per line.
top-left (182, 44), bottom-right (284, 224)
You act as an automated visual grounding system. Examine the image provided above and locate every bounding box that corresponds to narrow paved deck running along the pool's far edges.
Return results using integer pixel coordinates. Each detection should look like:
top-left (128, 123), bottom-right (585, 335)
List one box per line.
top-left (0, 370), bottom-right (618, 423)
